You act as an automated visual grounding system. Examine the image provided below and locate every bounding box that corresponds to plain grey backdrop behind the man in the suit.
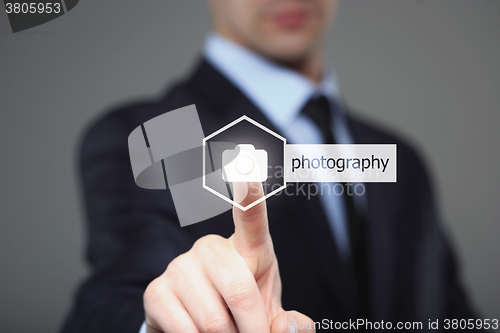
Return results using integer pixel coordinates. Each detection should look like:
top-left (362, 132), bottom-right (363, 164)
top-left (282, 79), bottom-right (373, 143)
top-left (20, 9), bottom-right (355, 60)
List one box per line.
top-left (0, 0), bottom-right (500, 332)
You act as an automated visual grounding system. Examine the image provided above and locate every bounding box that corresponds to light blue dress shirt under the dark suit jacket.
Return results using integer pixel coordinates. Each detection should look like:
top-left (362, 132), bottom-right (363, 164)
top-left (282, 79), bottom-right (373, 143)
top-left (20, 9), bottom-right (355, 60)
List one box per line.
top-left (139, 33), bottom-right (352, 333)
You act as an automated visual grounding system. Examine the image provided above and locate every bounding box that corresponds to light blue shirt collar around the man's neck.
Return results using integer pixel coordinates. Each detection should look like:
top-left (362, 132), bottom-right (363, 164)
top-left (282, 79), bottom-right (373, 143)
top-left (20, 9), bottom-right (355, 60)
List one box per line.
top-left (204, 33), bottom-right (340, 129)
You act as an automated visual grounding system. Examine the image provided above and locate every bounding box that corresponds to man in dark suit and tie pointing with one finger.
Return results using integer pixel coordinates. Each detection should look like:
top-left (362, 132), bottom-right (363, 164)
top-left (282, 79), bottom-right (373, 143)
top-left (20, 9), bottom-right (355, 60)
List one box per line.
top-left (63, 0), bottom-right (476, 333)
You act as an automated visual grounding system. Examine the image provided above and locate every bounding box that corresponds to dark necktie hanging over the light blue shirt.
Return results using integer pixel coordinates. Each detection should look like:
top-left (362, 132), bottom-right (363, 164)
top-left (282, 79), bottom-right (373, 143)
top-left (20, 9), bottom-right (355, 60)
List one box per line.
top-left (302, 96), bottom-right (369, 319)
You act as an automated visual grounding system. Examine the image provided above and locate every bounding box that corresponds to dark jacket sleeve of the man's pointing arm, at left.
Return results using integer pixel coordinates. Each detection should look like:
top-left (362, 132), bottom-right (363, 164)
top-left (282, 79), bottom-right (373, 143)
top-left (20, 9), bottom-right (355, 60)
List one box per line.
top-left (59, 107), bottom-right (192, 333)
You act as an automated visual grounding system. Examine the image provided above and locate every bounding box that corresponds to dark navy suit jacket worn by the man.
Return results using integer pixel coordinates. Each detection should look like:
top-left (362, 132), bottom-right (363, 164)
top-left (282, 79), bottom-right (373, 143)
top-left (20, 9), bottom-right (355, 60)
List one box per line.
top-left (63, 60), bottom-right (475, 333)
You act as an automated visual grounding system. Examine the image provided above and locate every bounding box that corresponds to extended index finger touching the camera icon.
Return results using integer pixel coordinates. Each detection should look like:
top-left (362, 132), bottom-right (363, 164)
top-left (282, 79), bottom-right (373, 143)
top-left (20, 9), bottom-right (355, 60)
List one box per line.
top-left (233, 182), bottom-right (271, 257)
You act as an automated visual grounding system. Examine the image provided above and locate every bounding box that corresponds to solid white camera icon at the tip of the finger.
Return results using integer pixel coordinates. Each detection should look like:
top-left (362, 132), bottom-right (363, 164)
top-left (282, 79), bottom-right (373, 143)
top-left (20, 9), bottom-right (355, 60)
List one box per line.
top-left (222, 144), bottom-right (268, 182)
